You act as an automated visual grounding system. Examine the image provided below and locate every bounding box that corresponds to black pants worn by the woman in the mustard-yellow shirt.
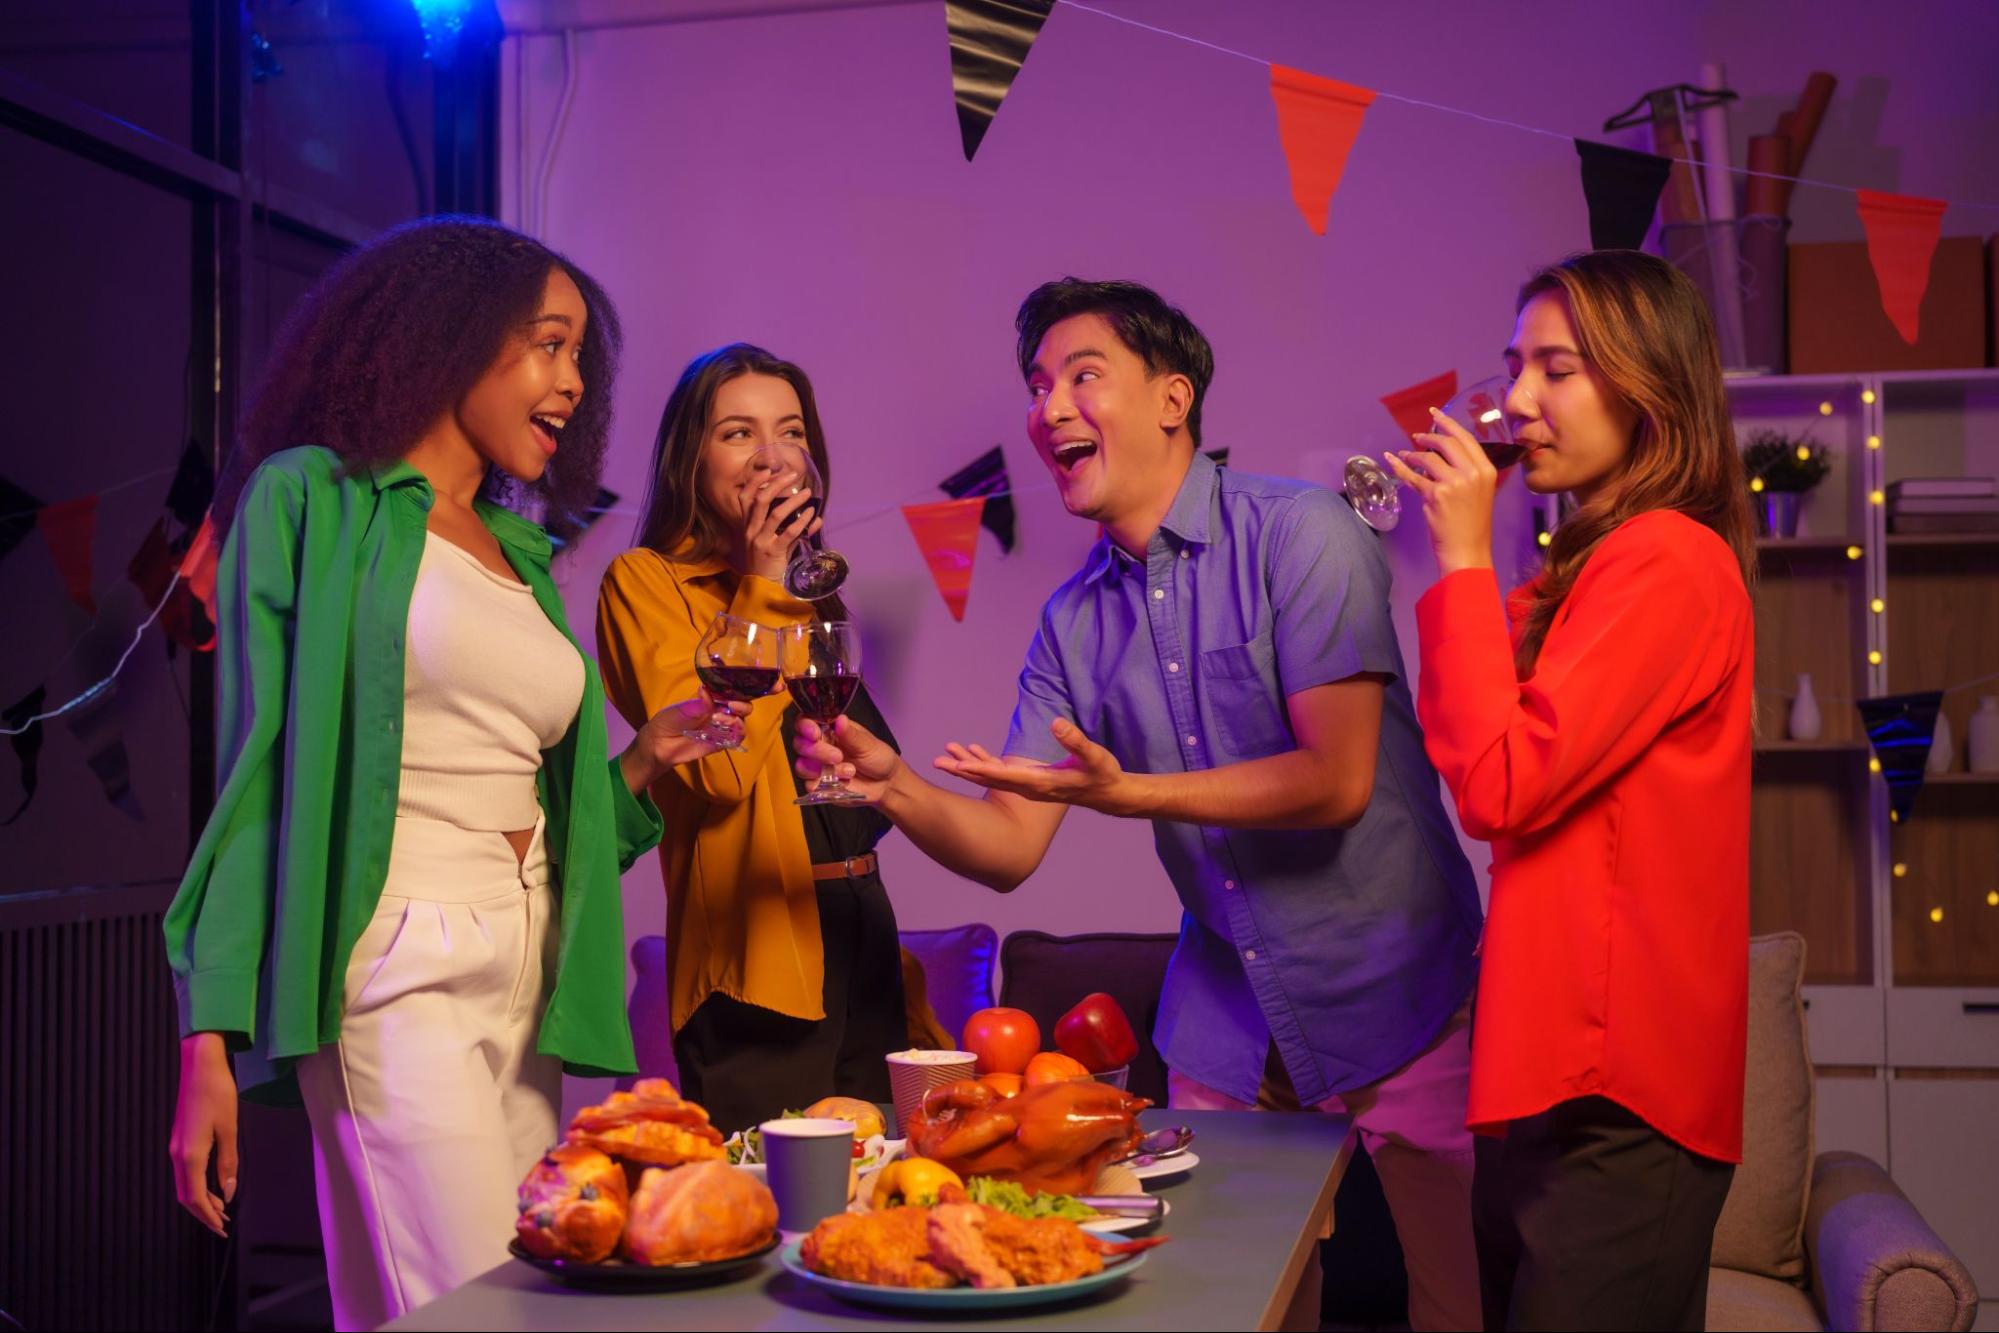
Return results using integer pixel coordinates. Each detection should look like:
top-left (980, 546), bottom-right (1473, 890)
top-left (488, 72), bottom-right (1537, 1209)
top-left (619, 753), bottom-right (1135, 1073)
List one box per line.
top-left (674, 875), bottom-right (910, 1133)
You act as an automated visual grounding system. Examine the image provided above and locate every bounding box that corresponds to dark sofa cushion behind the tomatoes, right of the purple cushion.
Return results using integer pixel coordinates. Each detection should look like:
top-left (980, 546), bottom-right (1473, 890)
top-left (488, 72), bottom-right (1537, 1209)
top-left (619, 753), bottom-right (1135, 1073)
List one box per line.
top-left (1000, 931), bottom-right (1179, 1105)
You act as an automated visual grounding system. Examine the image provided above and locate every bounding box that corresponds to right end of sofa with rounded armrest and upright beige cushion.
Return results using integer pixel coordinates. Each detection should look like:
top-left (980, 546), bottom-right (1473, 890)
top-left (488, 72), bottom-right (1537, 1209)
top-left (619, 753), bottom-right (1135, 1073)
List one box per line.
top-left (1707, 933), bottom-right (1979, 1329)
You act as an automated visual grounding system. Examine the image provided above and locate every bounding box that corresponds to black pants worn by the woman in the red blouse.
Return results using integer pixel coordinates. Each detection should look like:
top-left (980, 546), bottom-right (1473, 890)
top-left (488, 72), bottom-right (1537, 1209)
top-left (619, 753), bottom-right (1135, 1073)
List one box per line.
top-left (1471, 1097), bottom-right (1735, 1331)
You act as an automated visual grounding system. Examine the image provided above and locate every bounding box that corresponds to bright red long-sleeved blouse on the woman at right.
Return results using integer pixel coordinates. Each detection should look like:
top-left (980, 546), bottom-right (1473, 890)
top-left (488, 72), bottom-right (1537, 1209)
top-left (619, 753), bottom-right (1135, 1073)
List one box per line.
top-left (1415, 510), bottom-right (1755, 1161)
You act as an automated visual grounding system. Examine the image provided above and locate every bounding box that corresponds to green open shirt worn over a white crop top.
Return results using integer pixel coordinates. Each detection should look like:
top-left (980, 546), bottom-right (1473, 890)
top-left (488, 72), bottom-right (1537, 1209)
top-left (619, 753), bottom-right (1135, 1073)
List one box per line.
top-left (166, 448), bottom-right (662, 1101)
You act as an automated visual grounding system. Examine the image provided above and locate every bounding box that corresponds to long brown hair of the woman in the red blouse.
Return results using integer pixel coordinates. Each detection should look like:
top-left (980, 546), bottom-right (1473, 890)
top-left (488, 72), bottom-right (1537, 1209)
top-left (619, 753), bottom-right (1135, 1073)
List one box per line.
top-left (1513, 250), bottom-right (1755, 675)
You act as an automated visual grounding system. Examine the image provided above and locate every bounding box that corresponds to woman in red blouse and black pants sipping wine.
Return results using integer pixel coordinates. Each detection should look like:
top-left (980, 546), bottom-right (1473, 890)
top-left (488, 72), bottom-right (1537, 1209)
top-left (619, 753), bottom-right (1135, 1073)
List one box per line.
top-left (1391, 250), bottom-right (1755, 1329)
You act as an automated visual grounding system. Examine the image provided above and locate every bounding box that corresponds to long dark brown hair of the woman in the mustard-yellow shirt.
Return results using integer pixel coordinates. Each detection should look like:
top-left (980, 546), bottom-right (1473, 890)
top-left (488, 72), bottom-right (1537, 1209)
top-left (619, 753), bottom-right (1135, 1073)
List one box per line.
top-left (638, 342), bottom-right (834, 562)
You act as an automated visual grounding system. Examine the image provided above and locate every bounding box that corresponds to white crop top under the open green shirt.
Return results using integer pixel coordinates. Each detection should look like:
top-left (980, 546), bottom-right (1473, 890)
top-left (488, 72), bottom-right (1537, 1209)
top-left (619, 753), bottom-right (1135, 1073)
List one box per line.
top-left (396, 532), bottom-right (584, 833)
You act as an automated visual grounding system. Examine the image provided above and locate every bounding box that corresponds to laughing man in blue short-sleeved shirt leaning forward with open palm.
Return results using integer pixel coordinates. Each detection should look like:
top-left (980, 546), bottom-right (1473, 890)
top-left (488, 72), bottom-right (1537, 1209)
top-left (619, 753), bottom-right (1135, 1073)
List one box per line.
top-left (798, 278), bottom-right (1479, 1329)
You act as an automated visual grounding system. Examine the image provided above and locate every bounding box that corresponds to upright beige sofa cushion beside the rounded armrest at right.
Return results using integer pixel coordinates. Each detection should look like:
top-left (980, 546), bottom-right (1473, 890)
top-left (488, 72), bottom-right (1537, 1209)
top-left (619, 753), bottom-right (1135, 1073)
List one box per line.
top-left (1713, 931), bottom-right (1813, 1279)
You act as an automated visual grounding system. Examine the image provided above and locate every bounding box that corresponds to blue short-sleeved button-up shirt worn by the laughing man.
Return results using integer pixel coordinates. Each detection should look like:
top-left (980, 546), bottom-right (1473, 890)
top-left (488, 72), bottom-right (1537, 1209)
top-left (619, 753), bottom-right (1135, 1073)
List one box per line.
top-left (1005, 454), bottom-right (1479, 1105)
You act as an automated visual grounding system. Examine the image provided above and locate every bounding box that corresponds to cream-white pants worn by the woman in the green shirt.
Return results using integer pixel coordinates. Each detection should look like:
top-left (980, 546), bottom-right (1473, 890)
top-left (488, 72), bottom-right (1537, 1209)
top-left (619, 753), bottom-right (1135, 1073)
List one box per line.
top-left (298, 819), bottom-right (562, 1329)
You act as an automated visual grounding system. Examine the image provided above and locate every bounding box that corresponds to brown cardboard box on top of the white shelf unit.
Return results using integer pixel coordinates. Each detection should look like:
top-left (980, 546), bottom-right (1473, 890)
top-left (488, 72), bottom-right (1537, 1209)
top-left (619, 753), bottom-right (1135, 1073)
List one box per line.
top-left (1789, 236), bottom-right (1993, 376)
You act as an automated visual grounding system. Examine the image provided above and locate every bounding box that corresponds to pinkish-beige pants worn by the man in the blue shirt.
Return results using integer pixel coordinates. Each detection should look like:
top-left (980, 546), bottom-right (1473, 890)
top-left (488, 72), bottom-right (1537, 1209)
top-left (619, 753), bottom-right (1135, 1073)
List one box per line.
top-left (1167, 1005), bottom-right (1483, 1333)
